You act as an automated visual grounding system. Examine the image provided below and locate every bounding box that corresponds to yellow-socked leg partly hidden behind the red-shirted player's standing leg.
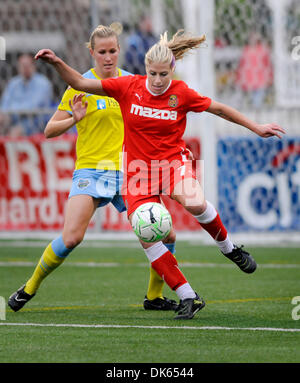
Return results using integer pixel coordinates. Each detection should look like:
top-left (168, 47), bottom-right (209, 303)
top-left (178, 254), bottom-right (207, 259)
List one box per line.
top-left (144, 229), bottom-right (178, 310)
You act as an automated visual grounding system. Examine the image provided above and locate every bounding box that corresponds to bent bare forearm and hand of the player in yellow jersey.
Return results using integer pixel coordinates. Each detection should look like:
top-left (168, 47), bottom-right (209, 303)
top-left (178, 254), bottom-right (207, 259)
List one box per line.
top-left (44, 94), bottom-right (88, 138)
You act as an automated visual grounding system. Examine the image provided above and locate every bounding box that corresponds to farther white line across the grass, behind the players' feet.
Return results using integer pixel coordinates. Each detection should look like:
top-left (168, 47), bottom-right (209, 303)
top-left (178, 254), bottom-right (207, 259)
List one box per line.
top-left (0, 261), bottom-right (300, 269)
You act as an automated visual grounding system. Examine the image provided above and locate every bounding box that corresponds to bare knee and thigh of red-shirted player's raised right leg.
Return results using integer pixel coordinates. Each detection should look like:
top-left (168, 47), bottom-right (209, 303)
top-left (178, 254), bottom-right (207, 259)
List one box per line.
top-left (171, 177), bottom-right (206, 215)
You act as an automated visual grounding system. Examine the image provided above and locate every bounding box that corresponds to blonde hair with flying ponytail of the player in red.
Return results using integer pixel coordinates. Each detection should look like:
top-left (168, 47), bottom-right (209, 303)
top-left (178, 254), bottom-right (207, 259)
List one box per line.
top-left (145, 29), bottom-right (205, 67)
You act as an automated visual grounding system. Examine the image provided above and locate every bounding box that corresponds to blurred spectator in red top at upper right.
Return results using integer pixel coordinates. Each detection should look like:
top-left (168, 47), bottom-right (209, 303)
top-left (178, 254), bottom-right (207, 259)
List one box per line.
top-left (236, 32), bottom-right (273, 108)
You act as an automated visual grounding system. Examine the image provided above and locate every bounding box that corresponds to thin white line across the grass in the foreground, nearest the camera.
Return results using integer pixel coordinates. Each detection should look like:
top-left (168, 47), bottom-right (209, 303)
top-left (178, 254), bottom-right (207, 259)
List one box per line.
top-left (0, 322), bottom-right (300, 332)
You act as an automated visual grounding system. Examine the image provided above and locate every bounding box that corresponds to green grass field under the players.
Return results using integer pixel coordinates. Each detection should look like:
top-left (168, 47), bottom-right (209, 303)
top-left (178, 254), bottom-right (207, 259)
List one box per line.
top-left (0, 241), bottom-right (300, 363)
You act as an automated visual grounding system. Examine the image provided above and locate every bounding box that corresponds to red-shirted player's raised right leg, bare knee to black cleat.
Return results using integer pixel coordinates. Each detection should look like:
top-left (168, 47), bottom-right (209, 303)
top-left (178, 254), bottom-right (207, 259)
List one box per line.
top-left (171, 178), bottom-right (256, 273)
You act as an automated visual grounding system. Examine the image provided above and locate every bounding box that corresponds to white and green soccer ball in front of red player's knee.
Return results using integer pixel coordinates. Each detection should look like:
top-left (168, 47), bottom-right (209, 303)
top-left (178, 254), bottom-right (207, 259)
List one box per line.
top-left (131, 202), bottom-right (172, 242)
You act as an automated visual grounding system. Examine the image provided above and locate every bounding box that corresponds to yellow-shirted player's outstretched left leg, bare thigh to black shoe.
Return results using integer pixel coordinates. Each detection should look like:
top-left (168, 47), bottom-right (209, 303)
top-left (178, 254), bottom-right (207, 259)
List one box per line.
top-left (8, 195), bottom-right (98, 311)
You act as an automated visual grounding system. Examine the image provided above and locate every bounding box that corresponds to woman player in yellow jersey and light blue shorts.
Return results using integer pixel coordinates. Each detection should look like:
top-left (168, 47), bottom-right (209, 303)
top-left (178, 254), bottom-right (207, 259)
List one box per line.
top-left (8, 24), bottom-right (177, 311)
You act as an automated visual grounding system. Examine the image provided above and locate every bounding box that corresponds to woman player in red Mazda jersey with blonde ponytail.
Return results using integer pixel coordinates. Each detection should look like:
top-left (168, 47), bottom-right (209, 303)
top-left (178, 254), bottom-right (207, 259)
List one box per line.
top-left (36, 31), bottom-right (285, 319)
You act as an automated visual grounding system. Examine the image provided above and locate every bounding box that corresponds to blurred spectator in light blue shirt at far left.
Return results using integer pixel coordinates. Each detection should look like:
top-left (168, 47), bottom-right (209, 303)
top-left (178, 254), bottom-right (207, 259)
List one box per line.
top-left (0, 54), bottom-right (53, 136)
